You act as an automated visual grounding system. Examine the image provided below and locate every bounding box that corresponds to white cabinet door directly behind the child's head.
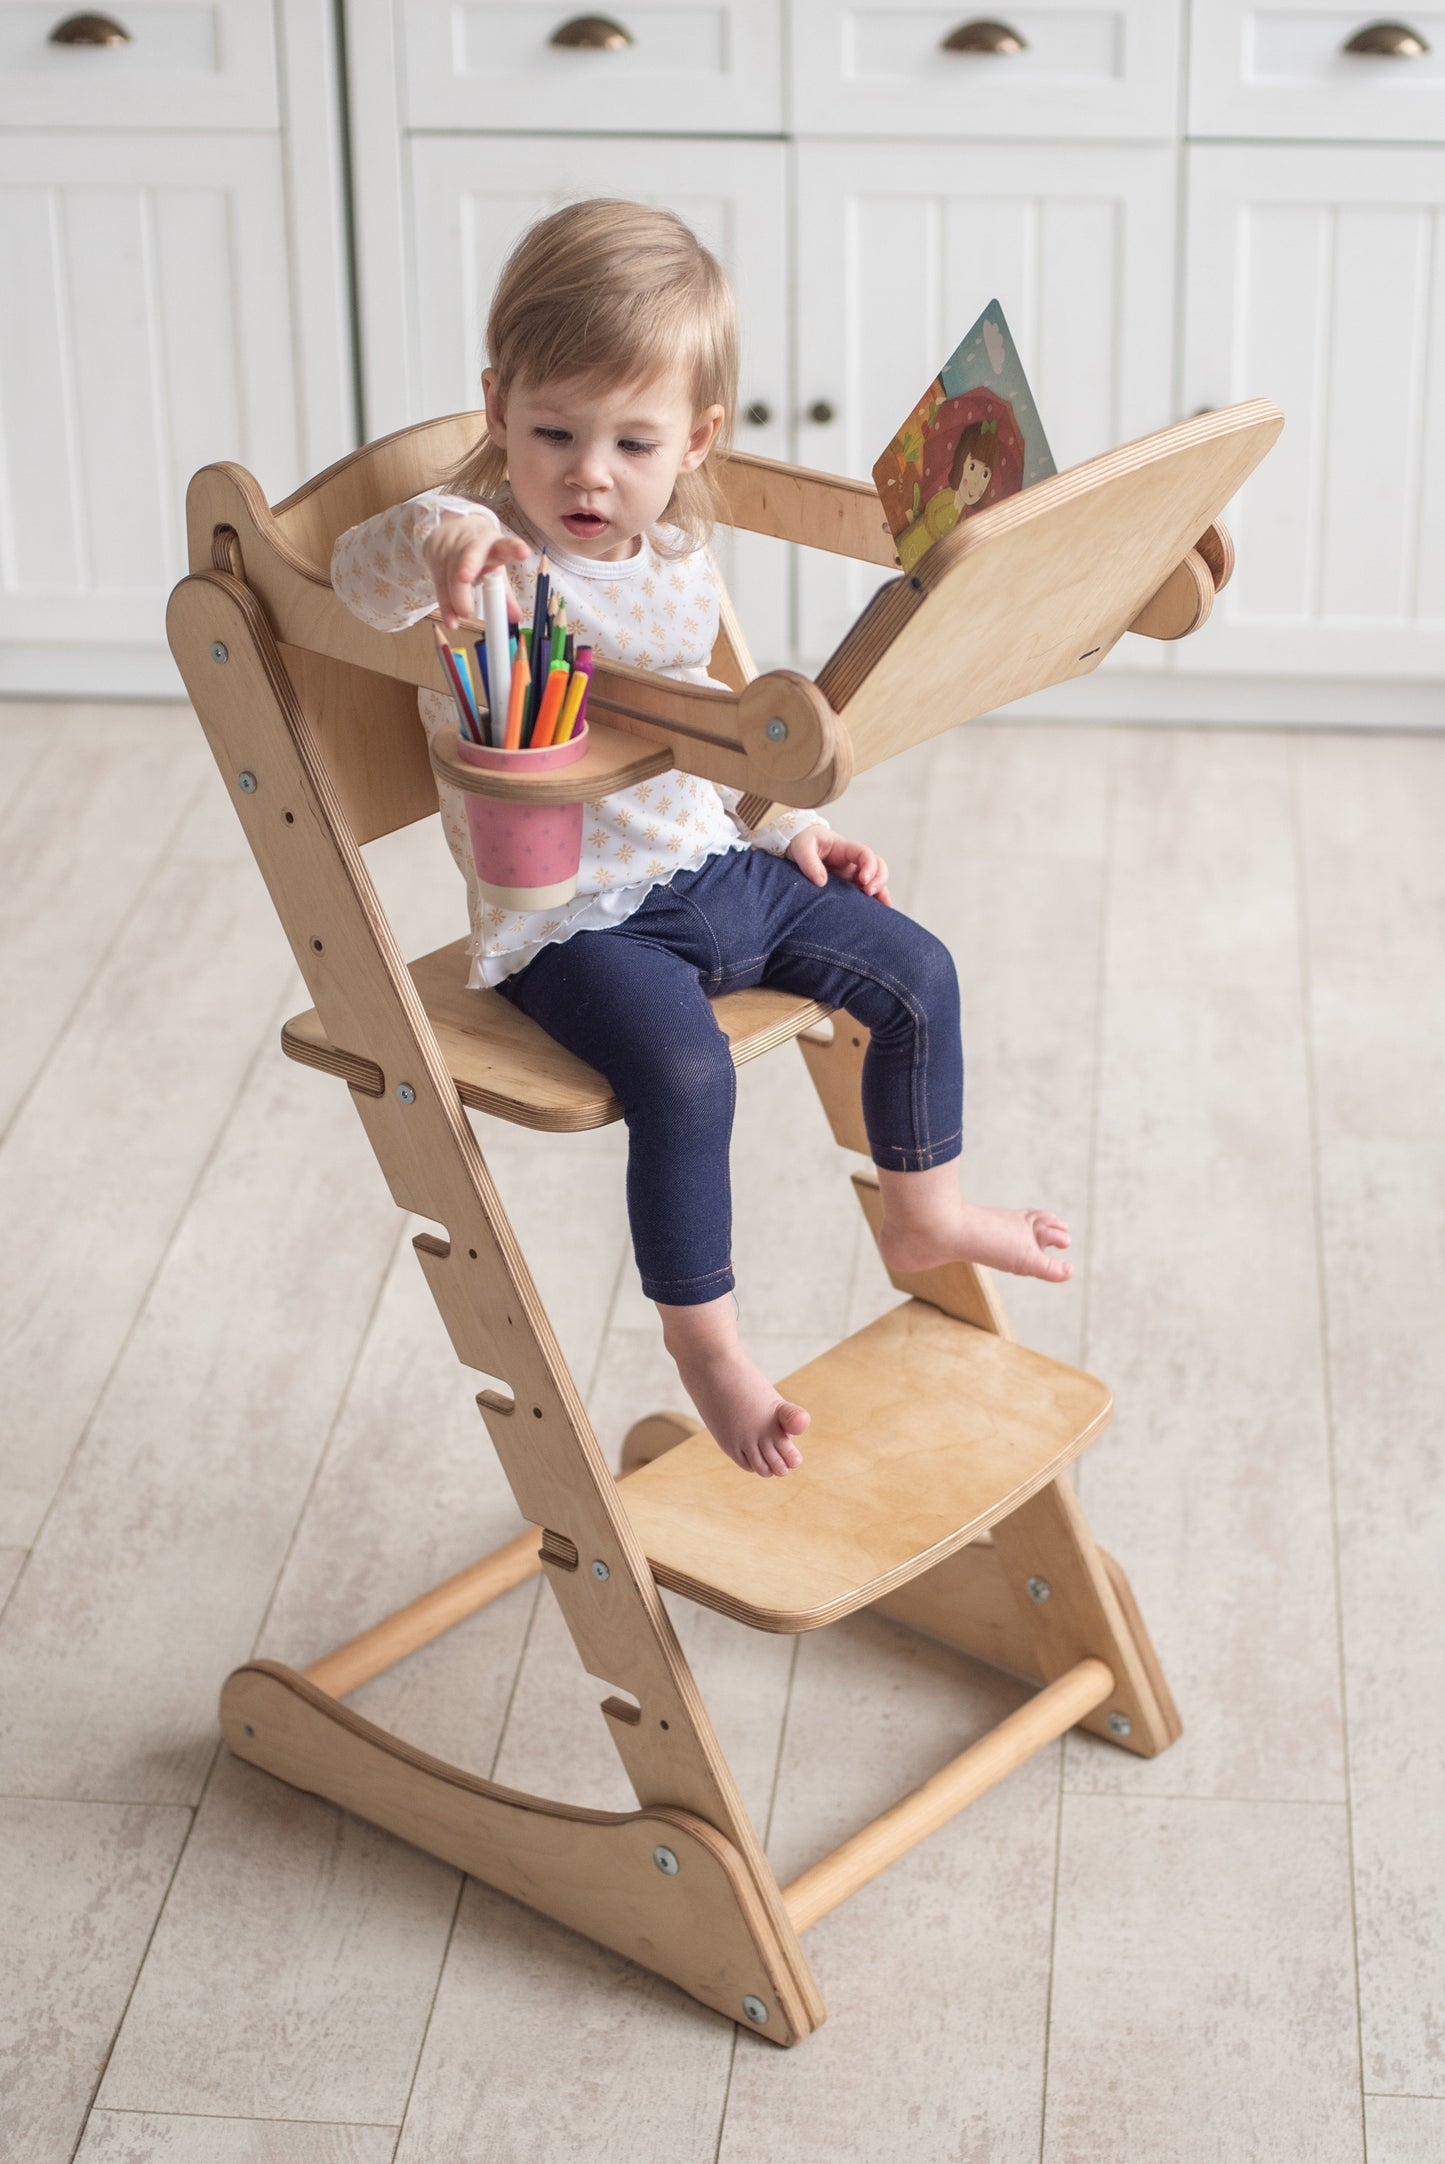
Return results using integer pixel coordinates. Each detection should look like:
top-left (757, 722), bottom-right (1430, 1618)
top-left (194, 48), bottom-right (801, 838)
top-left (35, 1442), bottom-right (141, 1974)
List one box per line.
top-left (409, 136), bottom-right (790, 667)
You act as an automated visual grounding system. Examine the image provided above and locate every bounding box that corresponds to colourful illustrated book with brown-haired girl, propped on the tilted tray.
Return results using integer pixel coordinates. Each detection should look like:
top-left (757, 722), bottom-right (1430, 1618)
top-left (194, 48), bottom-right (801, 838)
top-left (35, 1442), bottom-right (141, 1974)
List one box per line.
top-left (874, 301), bottom-right (1058, 571)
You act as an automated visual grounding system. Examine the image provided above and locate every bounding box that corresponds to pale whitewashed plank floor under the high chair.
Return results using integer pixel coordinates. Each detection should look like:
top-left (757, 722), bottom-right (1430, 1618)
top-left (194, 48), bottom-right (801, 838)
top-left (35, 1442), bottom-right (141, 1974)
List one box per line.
top-left (0, 705), bottom-right (1445, 2164)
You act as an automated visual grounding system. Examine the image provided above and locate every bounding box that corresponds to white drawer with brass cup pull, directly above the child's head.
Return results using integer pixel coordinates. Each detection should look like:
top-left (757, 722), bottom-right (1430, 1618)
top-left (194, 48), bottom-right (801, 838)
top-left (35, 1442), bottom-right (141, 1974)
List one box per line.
top-left (402, 0), bottom-right (783, 136)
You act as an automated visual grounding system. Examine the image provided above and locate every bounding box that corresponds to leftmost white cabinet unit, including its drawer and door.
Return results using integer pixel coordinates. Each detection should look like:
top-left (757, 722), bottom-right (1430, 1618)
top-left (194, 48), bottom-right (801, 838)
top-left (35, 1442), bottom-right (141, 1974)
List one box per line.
top-left (0, 0), bottom-right (357, 697)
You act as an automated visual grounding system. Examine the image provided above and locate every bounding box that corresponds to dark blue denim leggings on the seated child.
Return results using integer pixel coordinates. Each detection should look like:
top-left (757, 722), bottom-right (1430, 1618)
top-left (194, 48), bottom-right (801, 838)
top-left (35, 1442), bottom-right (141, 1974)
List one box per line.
top-left (502, 848), bottom-right (963, 1307)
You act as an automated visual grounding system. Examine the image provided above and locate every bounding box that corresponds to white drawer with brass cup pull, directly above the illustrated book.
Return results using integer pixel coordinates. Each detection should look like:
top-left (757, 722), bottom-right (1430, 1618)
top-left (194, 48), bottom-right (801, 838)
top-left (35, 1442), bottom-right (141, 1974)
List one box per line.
top-left (790, 0), bottom-right (1179, 143)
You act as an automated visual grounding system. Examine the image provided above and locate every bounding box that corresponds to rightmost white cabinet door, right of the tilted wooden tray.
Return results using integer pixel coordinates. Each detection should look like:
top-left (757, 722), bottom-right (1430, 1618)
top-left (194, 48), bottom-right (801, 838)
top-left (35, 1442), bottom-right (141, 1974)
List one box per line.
top-left (1179, 145), bottom-right (1445, 677)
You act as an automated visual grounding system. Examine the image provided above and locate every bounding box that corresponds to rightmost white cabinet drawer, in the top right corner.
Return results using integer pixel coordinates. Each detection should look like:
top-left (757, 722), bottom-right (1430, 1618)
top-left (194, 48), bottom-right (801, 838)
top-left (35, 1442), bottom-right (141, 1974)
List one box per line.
top-left (1190, 0), bottom-right (1445, 143)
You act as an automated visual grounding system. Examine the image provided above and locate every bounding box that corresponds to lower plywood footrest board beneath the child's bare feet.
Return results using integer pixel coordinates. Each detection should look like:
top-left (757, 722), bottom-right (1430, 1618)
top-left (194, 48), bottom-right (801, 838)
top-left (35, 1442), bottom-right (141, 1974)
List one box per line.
top-left (621, 1301), bottom-right (1114, 1632)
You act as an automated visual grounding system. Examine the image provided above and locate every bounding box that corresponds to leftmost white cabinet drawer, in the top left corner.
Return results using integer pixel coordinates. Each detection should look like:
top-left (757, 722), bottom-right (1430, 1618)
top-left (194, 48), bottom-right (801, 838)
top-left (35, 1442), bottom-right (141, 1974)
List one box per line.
top-left (0, 0), bottom-right (279, 130)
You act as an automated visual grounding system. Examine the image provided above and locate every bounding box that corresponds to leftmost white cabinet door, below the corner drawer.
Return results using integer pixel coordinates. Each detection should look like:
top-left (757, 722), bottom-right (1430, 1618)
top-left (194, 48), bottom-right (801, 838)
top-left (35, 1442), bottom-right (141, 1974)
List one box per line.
top-left (0, 134), bottom-right (303, 647)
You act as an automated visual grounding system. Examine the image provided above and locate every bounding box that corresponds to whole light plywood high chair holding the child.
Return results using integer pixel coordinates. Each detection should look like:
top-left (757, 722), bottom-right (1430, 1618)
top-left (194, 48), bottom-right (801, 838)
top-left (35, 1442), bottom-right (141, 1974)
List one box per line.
top-left (169, 400), bottom-right (1281, 2043)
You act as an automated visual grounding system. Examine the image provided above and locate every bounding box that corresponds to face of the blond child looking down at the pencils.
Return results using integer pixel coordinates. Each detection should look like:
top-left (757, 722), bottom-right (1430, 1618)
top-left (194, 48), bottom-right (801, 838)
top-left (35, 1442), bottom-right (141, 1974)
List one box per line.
top-left (482, 368), bottom-right (723, 563)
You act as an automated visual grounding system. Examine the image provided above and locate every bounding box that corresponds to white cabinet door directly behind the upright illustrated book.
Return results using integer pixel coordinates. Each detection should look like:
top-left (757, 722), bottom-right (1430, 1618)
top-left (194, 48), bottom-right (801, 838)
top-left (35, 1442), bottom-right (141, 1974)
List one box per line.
top-left (798, 143), bottom-right (1175, 667)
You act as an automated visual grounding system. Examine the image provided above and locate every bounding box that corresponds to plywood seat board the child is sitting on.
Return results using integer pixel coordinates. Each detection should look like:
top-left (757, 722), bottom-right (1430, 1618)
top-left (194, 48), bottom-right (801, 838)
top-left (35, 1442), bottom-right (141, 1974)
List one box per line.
top-left (281, 939), bottom-right (831, 1134)
